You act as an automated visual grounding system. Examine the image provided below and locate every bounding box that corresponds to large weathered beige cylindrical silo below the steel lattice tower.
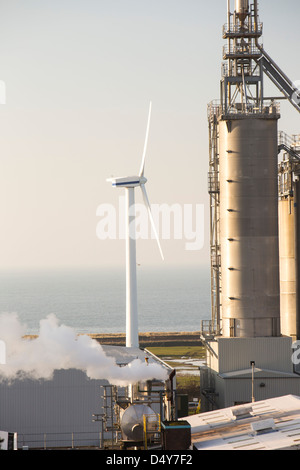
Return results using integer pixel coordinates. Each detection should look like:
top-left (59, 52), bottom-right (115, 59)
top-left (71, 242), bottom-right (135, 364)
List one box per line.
top-left (219, 115), bottom-right (280, 337)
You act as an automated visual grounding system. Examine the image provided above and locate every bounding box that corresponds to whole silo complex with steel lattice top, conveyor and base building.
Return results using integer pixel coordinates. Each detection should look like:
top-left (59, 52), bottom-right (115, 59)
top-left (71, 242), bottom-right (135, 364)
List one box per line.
top-left (201, 0), bottom-right (300, 411)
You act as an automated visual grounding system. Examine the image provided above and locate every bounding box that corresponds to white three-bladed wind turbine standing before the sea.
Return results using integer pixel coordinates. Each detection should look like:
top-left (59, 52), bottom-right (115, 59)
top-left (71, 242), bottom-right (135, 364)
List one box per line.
top-left (107, 102), bottom-right (164, 348)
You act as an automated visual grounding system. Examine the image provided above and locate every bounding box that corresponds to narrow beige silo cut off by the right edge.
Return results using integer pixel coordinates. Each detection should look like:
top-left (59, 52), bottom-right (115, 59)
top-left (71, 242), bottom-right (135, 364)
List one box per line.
top-left (278, 197), bottom-right (297, 340)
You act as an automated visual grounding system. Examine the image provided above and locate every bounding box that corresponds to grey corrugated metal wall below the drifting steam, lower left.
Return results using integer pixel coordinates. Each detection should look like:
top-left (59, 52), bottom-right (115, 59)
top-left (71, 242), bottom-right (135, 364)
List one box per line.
top-left (0, 370), bottom-right (106, 447)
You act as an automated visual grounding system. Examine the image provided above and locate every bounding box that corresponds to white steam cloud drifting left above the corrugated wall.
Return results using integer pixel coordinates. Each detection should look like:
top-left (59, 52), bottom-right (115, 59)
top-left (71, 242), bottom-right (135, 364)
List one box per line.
top-left (0, 314), bottom-right (167, 386)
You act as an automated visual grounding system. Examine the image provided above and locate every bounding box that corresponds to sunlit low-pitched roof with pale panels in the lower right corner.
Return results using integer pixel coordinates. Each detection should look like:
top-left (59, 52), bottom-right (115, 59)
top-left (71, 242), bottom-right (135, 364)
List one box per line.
top-left (184, 395), bottom-right (300, 450)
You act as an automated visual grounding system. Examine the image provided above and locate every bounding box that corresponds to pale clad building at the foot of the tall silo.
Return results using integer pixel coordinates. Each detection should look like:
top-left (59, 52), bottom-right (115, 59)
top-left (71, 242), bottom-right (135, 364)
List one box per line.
top-left (203, 337), bottom-right (300, 410)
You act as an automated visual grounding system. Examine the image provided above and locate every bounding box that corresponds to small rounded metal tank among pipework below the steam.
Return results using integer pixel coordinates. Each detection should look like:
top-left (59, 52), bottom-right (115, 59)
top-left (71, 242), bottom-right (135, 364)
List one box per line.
top-left (121, 404), bottom-right (158, 441)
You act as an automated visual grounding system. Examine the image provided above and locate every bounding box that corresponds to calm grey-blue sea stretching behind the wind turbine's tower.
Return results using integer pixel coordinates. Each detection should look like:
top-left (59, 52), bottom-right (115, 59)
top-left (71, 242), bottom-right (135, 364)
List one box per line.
top-left (0, 266), bottom-right (211, 334)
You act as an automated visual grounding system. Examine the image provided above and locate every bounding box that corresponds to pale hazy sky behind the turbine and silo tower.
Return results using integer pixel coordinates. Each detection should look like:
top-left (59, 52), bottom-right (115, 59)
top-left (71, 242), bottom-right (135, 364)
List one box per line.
top-left (0, 0), bottom-right (300, 268)
